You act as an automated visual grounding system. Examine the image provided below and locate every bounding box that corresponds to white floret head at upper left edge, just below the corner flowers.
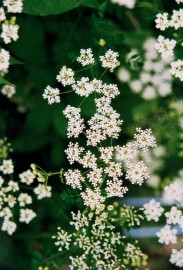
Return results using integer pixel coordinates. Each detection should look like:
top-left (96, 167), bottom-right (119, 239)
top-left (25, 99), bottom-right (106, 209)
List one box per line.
top-left (1, 22), bottom-right (19, 44)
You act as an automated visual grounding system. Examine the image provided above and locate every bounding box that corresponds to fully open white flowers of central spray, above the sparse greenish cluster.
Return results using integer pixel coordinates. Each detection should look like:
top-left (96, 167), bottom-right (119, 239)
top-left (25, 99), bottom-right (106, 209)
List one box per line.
top-left (48, 49), bottom-right (156, 211)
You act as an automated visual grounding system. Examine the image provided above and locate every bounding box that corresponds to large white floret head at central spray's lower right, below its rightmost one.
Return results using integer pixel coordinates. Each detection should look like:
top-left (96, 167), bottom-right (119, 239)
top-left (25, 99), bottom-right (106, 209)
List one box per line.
top-left (125, 161), bottom-right (149, 186)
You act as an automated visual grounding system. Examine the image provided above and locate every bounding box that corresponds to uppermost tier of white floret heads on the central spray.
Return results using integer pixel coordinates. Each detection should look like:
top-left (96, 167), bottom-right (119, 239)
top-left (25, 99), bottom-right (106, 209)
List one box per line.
top-left (43, 48), bottom-right (119, 104)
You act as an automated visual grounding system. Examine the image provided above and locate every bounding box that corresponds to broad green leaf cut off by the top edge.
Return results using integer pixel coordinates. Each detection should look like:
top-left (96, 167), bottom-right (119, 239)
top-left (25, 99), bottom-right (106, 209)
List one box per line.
top-left (23, 0), bottom-right (99, 16)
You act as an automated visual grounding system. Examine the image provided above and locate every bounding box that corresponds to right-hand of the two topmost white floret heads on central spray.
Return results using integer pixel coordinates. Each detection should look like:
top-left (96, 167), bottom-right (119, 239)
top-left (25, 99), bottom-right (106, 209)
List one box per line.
top-left (100, 49), bottom-right (119, 69)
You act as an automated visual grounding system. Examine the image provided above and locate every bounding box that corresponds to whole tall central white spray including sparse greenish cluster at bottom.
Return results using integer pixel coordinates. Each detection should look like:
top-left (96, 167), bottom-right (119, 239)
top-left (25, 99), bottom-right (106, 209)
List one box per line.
top-left (40, 48), bottom-right (156, 270)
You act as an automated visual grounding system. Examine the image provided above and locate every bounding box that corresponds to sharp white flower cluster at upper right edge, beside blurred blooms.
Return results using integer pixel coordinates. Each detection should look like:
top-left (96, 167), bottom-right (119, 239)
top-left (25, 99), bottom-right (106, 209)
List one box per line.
top-left (155, 5), bottom-right (183, 81)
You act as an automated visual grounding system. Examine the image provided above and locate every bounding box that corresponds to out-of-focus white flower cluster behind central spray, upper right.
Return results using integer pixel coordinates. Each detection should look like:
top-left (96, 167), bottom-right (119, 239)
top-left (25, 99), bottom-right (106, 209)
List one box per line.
top-left (117, 38), bottom-right (172, 100)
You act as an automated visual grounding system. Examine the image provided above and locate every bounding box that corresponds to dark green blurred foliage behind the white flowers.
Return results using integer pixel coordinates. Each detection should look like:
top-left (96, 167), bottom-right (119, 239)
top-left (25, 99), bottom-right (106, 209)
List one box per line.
top-left (0, 0), bottom-right (182, 270)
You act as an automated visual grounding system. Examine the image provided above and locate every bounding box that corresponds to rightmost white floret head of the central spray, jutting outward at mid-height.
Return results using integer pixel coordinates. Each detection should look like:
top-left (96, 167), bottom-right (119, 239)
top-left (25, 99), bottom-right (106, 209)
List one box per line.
top-left (134, 128), bottom-right (156, 151)
